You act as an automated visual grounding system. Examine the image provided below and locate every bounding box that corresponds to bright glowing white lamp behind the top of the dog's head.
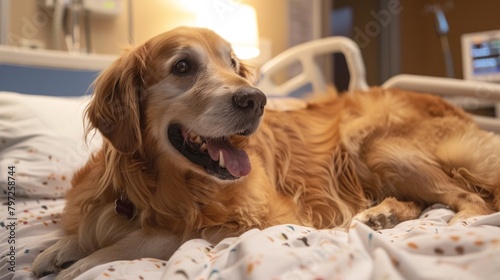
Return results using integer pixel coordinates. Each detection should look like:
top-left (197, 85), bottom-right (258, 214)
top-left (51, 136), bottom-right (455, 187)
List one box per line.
top-left (196, 0), bottom-right (260, 59)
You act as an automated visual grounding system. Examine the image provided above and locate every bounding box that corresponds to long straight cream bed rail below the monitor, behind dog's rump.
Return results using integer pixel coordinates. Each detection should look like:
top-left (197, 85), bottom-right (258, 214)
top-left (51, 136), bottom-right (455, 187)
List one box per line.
top-left (382, 74), bottom-right (500, 133)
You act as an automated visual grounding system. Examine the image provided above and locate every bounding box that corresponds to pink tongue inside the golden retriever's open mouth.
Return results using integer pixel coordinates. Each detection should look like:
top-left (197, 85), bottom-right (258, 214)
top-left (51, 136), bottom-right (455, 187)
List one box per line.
top-left (207, 140), bottom-right (252, 177)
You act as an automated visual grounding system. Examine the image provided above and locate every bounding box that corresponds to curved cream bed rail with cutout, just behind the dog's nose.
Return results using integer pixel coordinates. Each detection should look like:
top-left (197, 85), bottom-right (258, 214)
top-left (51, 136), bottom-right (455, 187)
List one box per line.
top-left (257, 36), bottom-right (368, 96)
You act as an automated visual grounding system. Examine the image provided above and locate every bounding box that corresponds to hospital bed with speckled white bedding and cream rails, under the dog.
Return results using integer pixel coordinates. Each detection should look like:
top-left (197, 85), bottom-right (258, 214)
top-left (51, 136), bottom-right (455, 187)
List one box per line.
top-left (0, 37), bottom-right (500, 280)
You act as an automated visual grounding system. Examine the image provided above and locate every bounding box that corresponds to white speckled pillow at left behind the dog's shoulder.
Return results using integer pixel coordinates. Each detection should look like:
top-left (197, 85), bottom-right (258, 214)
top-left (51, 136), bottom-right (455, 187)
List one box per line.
top-left (0, 92), bottom-right (102, 198)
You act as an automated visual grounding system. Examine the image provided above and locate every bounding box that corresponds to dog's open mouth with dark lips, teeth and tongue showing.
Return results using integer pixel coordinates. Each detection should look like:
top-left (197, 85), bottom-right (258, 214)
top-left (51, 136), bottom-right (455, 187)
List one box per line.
top-left (168, 124), bottom-right (252, 180)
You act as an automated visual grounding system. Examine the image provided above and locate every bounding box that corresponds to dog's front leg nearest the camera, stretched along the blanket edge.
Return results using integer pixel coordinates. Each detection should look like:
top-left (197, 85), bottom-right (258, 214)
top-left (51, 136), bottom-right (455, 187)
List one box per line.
top-left (51, 230), bottom-right (181, 280)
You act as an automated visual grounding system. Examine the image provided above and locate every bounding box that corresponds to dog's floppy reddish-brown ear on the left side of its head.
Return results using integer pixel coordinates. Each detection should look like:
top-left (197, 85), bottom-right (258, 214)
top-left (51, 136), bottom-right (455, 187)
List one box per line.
top-left (86, 47), bottom-right (145, 153)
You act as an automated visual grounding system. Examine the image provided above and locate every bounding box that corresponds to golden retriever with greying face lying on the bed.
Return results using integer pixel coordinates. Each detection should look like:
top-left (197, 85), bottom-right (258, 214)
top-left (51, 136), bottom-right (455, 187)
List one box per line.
top-left (32, 27), bottom-right (500, 279)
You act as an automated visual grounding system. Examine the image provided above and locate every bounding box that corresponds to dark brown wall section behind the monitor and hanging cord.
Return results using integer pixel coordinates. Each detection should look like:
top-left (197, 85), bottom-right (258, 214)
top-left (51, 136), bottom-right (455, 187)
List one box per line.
top-left (400, 0), bottom-right (500, 78)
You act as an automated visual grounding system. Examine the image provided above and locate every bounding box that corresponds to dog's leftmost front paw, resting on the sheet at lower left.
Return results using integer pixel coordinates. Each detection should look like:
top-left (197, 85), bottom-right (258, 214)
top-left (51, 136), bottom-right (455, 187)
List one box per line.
top-left (31, 237), bottom-right (82, 278)
